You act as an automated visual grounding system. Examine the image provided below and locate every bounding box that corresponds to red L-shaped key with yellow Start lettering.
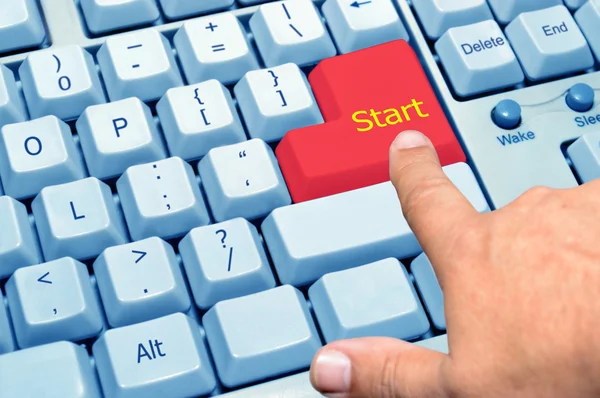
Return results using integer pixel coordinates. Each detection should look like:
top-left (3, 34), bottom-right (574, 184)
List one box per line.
top-left (276, 40), bottom-right (465, 202)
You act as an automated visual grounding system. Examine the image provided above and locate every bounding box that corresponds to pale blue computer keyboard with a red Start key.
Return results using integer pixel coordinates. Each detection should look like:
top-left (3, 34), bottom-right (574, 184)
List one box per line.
top-left (0, 0), bottom-right (600, 398)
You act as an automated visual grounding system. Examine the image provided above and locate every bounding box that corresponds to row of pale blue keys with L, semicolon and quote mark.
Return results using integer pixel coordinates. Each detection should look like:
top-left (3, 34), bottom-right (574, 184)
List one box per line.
top-left (0, 145), bottom-right (291, 262)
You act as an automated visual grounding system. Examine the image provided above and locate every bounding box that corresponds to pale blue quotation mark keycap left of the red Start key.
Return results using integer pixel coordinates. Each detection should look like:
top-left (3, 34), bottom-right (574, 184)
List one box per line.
top-left (198, 139), bottom-right (292, 221)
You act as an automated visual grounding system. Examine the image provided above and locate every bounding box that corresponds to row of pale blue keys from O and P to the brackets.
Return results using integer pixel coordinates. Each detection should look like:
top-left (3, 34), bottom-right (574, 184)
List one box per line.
top-left (0, 70), bottom-right (323, 199)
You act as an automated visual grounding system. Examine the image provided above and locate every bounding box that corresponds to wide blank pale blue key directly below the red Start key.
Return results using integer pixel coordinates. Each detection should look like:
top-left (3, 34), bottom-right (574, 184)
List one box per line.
top-left (262, 163), bottom-right (489, 286)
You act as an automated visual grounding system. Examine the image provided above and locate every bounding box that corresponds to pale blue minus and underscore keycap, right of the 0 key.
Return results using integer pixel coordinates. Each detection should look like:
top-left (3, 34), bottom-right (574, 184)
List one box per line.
top-left (96, 29), bottom-right (183, 102)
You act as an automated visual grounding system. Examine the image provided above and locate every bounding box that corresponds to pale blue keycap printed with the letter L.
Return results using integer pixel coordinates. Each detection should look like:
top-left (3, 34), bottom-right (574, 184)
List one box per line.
top-left (31, 177), bottom-right (129, 260)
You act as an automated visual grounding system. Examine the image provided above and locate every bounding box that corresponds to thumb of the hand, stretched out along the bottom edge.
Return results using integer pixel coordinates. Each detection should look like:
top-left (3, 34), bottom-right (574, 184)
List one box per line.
top-left (310, 337), bottom-right (448, 398)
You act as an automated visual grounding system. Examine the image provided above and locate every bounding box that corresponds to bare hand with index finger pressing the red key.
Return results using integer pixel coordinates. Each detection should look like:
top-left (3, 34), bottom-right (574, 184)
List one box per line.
top-left (310, 131), bottom-right (600, 398)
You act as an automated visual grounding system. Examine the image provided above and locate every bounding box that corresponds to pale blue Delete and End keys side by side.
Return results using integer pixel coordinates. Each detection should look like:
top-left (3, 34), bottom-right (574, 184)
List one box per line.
top-left (435, 3), bottom-right (600, 97)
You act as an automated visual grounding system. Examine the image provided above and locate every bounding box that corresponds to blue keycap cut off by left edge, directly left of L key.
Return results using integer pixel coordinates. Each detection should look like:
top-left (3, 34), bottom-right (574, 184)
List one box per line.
top-left (0, 196), bottom-right (42, 279)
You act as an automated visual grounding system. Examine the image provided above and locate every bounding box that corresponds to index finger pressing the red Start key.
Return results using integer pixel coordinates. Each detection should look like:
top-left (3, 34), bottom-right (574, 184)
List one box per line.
top-left (390, 131), bottom-right (479, 278)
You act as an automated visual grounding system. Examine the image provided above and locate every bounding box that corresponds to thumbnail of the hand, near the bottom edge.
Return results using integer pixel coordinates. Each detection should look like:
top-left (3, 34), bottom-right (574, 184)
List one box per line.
top-left (312, 350), bottom-right (350, 397)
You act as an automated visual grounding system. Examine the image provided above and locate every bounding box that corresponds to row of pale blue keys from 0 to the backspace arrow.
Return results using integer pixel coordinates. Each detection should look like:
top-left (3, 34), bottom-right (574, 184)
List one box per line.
top-left (0, 0), bottom-right (418, 126)
